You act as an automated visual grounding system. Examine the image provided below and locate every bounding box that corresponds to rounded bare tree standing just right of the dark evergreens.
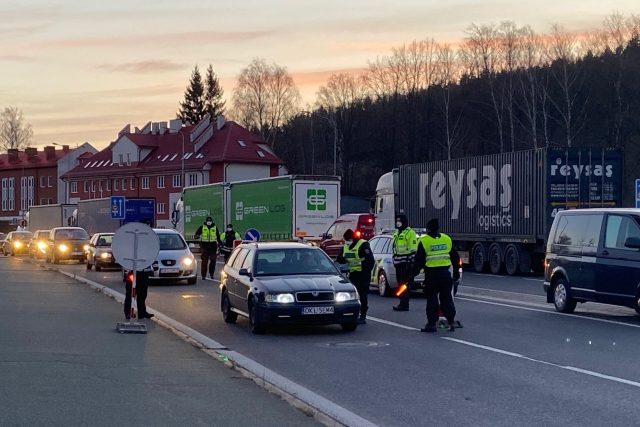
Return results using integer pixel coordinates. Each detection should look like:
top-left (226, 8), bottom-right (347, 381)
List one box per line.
top-left (232, 58), bottom-right (300, 148)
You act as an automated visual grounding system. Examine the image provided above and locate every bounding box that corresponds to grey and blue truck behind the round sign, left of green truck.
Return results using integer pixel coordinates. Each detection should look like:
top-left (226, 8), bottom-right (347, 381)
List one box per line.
top-left (73, 198), bottom-right (155, 235)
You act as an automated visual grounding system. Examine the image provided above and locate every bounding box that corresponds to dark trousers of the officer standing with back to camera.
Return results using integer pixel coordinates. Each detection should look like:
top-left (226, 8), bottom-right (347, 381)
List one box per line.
top-left (424, 267), bottom-right (456, 326)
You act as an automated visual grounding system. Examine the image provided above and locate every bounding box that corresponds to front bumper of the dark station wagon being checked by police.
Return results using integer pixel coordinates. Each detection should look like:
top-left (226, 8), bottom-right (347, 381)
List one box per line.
top-left (257, 301), bottom-right (360, 325)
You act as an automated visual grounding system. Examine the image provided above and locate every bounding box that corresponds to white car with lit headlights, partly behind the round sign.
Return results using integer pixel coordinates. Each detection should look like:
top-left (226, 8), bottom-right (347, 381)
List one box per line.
top-left (150, 228), bottom-right (198, 285)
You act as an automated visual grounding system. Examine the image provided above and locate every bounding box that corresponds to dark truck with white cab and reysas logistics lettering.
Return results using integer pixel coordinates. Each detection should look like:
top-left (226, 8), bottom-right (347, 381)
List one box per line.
top-left (375, 147), bottom-right (623, 275)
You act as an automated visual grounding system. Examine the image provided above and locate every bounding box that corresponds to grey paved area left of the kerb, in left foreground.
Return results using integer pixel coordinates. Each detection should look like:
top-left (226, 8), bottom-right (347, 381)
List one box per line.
top-left (0, 257), bottom-right (317, 426)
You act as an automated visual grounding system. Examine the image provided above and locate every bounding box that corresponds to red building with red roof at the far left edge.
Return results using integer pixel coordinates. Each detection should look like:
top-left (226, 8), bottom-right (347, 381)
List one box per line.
top-left (0, 143), bottom-right (97, 232)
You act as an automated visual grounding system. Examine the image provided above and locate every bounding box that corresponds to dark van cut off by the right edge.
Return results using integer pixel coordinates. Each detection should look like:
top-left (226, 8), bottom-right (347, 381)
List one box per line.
top-left (544, 209), bottom-right (640, 313)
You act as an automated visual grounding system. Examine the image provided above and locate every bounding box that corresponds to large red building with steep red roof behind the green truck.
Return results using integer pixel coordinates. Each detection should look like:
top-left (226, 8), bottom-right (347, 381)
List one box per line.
top-left (63, 116), bottom-right (285, 228)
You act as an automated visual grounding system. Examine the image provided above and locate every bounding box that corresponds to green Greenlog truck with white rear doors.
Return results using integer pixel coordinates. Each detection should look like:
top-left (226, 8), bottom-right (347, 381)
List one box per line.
top-left (172, 175), bottom-right (340, 242)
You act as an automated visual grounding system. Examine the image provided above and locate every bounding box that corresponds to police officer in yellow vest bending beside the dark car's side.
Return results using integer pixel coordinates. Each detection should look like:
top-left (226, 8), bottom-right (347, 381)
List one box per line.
top-left (337, 229), bottom-right (375, 324)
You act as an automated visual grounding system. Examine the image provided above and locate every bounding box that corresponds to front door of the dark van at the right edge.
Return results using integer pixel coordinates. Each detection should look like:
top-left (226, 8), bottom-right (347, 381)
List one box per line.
top-left (596, 214), bottom-right (640, 306)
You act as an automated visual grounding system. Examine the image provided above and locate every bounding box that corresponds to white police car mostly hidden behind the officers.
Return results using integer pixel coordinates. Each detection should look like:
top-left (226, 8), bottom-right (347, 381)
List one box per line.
top-left (369, 234), bottom-right (462, 297)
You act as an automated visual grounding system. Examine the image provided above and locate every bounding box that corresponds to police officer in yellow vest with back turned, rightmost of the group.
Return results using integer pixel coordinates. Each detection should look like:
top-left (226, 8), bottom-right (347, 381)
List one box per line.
top-left (414, 218), bottom-right (460, 332)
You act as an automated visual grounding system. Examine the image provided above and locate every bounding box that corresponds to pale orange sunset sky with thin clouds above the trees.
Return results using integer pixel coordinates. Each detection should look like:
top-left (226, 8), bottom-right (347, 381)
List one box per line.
top-left (0, 0), bottom-right (640, 149)
